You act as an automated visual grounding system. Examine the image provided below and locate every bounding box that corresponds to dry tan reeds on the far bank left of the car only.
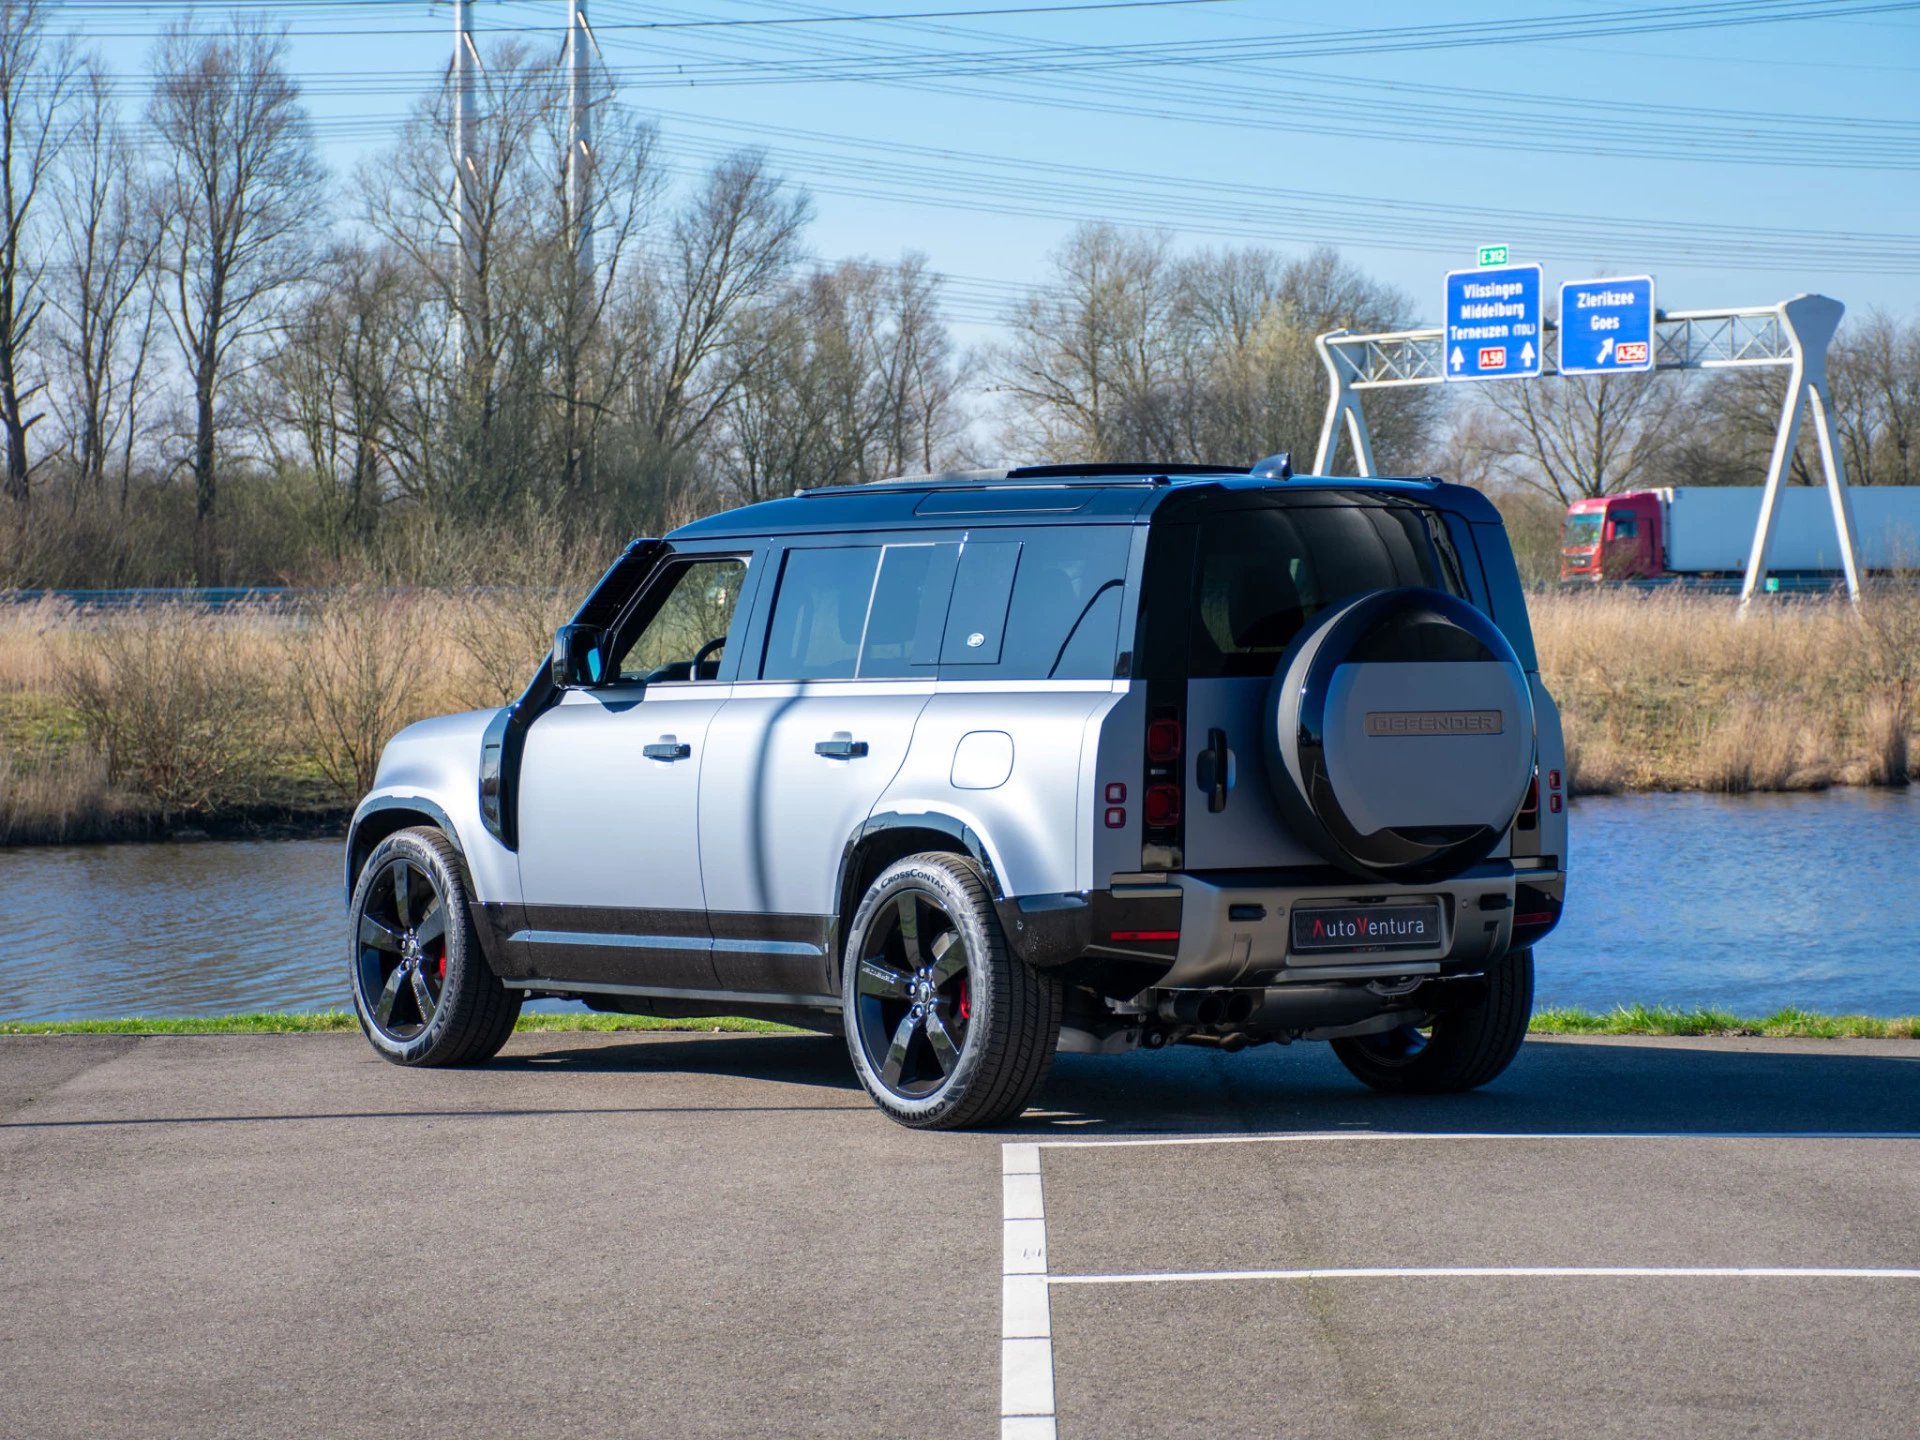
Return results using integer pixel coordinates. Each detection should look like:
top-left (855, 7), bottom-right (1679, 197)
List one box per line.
top-left (0, 584), bottom-right (555, 843)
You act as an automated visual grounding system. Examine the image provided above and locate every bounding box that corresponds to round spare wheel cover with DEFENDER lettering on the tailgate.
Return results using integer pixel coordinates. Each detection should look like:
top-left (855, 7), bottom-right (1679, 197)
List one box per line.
top-left (1263, 588), bottom-right (1534, 881)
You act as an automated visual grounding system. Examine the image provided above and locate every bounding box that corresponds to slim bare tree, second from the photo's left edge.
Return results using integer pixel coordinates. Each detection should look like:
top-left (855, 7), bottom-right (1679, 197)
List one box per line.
top-left (50, 63), bottom-right (159, 511)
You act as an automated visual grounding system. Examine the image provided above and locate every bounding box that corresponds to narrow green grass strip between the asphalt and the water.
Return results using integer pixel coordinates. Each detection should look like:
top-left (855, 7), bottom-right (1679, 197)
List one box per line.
top-left (0, 1004), bottom-right (1920, 1041)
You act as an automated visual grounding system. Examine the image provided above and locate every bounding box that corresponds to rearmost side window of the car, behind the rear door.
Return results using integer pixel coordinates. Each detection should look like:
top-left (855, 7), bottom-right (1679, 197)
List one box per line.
top-left (941, 526), bottom-right (1133, 680)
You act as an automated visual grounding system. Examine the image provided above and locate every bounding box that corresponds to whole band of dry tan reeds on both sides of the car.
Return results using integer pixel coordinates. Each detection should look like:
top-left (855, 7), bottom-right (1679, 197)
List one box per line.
top-left (0, 576), bottom-right (1920, 843)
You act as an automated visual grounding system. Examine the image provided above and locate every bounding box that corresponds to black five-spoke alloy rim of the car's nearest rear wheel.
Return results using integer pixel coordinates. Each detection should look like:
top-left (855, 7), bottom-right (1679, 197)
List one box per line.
top-left (854, 889), bottom-right (973, 1100)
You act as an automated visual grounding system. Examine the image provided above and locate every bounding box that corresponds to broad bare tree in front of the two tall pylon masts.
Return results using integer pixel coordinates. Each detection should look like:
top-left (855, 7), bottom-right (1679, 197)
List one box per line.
top-left (363, 44), bottom-right (659, 515)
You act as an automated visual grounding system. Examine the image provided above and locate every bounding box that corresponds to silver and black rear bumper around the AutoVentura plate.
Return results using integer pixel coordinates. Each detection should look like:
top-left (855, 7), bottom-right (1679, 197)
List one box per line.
top-left (1000, 860), bottom-right (1567, 989)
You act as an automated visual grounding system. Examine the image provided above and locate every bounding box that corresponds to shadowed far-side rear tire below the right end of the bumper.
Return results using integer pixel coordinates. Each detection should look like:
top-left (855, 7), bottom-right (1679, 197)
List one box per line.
top-left (1332, 950), bottom-right (1534, 1094)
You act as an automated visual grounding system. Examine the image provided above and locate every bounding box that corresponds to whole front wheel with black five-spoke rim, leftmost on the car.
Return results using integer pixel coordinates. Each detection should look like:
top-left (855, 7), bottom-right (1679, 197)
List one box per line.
top-left (348, 826), bottom-right (520, 1066)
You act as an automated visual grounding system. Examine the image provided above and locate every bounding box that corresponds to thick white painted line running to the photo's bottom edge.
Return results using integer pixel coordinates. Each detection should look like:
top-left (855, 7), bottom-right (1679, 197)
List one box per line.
top-left (1000, 1144), bottom-right (1056, 1440)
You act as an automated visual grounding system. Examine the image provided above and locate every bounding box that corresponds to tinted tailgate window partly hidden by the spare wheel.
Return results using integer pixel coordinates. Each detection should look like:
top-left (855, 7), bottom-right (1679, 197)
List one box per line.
top-left (1187, 505), bottom-right (1467, 680)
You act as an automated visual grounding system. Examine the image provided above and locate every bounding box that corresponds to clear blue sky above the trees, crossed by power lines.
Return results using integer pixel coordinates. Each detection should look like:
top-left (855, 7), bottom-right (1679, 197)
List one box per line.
top-left (54, 0), bottom-right (1920, 340)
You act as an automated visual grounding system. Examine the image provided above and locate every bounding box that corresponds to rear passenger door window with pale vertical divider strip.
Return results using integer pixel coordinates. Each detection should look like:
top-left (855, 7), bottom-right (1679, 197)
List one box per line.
top-left (760, 541), bottom-right (960, 680)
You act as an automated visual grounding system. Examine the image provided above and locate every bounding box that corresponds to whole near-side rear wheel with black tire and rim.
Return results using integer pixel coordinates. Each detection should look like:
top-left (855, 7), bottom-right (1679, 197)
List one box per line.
top-left (841, 854), bottom-right (1062, 1129)
